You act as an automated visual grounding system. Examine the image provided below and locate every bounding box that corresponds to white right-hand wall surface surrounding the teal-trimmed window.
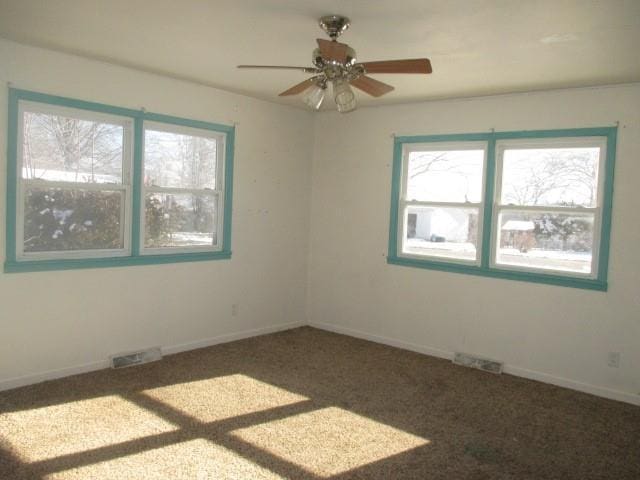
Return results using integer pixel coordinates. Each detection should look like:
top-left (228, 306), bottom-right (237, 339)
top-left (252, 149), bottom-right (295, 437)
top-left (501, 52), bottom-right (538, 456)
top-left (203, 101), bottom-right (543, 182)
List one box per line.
top-left (308, 84), bottom-right (640, 404)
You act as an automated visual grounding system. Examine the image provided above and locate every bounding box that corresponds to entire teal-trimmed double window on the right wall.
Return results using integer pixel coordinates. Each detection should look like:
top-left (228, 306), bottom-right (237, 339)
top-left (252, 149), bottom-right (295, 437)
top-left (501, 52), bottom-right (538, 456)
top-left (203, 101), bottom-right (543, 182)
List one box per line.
top-left (388, 128), bottom-right (616, 290)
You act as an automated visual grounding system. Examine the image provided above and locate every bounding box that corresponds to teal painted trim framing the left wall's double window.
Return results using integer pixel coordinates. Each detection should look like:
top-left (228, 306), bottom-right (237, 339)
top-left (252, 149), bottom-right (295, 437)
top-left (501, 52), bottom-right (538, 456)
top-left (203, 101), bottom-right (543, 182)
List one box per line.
top-left (4, 88), bottom-right (235, 273)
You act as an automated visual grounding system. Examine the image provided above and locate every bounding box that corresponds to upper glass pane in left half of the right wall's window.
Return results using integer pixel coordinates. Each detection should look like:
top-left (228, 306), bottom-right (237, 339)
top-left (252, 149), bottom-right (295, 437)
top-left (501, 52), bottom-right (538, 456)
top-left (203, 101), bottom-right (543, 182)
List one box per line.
top-left (407, 150), bottom-right (484, 202)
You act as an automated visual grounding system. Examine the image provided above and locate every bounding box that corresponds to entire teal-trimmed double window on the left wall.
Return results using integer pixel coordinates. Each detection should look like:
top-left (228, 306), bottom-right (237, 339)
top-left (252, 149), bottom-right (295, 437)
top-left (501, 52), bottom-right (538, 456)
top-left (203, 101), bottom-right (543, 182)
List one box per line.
top-left (5, 89), bottom-right (234, 272)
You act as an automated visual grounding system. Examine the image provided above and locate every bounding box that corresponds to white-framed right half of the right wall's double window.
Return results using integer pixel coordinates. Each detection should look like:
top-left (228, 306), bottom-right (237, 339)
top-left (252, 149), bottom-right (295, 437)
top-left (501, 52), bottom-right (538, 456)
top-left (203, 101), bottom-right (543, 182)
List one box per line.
top-left (492, 137), bottom-right (606, 278)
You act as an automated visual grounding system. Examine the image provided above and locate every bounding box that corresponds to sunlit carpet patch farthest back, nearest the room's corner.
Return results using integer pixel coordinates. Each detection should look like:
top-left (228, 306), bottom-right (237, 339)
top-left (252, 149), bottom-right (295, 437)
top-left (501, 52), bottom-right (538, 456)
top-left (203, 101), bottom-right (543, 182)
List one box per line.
top-left (142, 374), bottom-right (308, 423)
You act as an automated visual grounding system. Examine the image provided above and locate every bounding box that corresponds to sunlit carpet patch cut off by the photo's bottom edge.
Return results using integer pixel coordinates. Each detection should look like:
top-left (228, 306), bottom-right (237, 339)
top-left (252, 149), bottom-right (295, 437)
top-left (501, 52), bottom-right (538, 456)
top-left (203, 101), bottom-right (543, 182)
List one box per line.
top-left (46, 439), bottom-right (283, 480)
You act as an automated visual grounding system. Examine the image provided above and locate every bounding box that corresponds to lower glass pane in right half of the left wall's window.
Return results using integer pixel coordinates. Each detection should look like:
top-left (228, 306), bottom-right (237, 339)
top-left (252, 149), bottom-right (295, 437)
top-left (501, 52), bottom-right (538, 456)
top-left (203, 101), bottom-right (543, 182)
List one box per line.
top-left (144, 193), bottom-right (218, 248)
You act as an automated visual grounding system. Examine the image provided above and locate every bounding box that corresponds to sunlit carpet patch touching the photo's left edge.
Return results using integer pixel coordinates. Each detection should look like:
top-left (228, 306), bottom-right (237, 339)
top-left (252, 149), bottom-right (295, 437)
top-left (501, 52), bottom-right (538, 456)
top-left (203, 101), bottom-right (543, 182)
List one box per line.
top-left (0, 395), bottom-right (176, 462)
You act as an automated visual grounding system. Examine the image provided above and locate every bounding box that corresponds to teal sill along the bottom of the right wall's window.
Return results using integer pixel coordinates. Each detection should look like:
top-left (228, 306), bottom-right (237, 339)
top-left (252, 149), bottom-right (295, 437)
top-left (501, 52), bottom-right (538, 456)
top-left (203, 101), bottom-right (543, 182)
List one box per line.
top-left (387, 256), bottom-right (608, 292)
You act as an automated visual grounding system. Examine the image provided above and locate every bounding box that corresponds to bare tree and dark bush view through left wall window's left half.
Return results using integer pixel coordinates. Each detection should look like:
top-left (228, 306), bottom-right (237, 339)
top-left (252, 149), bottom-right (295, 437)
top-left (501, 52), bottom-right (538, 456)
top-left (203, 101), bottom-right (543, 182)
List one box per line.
top-left (21, 111), bottom-right (124, 253)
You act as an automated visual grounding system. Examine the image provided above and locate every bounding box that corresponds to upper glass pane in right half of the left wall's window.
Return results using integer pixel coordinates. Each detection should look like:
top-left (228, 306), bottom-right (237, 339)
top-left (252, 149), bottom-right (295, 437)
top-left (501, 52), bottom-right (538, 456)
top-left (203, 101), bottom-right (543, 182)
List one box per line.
top-left (144, 129), bottom-right (217, 189)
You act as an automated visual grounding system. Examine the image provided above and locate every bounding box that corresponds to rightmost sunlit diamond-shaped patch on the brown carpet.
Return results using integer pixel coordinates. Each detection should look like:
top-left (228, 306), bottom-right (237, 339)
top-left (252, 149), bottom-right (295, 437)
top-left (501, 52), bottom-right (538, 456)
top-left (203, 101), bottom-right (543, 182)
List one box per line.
top-left (232, 407), bottom-right (430, 477)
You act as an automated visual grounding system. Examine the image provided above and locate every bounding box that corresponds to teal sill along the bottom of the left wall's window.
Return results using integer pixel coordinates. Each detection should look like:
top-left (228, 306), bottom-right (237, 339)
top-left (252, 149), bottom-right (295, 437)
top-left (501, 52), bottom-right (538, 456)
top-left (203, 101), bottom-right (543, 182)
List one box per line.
top-left (4, 251), bottom-right (231, 273)
